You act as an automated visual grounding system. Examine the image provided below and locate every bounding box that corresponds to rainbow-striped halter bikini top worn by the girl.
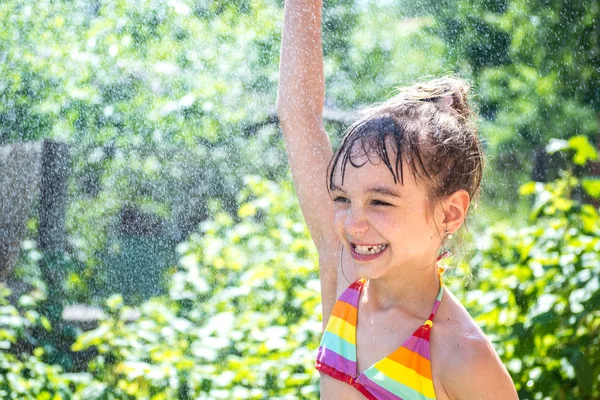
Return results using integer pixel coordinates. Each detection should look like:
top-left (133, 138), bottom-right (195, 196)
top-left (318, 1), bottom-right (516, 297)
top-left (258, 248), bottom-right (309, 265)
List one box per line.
top-left (315, 271), bottom-right (444, 400)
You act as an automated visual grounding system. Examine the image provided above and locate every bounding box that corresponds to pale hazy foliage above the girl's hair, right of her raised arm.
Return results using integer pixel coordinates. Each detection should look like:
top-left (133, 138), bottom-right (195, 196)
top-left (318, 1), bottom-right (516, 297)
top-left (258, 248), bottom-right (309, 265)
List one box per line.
top-left (323, 1), bottom-right (447, 110)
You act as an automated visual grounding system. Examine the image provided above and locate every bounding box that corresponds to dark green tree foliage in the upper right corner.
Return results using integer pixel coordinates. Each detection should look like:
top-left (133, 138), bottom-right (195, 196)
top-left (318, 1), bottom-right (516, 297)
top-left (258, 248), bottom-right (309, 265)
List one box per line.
top-left (428, 0), bottom-right (600, 208)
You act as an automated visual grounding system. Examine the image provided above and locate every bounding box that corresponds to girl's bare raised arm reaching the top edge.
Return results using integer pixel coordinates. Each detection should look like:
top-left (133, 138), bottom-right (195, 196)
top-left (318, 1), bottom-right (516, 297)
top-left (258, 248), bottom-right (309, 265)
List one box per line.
top-left (277, 0), bottom-right (337, 320)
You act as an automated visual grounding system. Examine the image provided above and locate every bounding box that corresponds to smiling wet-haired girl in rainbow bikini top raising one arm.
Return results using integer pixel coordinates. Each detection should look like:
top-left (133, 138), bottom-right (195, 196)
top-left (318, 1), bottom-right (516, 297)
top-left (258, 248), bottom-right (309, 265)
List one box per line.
top-left (277, 0), bottom-right (517, 400)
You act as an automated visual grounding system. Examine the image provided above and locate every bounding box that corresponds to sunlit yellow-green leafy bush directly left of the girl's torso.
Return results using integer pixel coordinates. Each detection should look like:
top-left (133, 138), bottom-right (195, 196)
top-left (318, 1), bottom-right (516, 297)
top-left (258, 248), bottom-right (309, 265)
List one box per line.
top-left (73, 177), bottom-right (321, 399)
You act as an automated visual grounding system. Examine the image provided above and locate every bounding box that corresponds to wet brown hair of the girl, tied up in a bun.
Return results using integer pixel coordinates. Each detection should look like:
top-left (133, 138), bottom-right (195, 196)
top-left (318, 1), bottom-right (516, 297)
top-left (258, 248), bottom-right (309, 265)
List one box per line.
top-left (327, 77), bottom-right (484, 216)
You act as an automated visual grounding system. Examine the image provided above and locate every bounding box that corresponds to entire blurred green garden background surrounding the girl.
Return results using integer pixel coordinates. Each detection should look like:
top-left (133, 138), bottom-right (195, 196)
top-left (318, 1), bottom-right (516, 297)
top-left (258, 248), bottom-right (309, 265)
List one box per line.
top-left (0, 0), bottom-right (600, 399)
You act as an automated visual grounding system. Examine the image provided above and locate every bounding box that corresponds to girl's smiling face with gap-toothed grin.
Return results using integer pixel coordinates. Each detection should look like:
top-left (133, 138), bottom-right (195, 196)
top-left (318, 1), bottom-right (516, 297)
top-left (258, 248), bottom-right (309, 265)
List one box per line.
top-left (331, 147), bottom-right (443, 279)
